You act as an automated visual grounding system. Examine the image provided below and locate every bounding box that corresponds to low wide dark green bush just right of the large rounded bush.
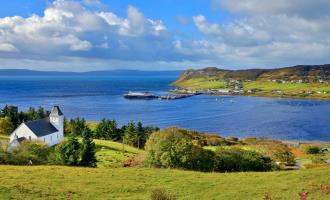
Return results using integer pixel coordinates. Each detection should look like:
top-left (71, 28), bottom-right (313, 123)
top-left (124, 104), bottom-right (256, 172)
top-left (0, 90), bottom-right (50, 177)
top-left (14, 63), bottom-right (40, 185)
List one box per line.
top-left (215, 148), bottom-right (273, 172)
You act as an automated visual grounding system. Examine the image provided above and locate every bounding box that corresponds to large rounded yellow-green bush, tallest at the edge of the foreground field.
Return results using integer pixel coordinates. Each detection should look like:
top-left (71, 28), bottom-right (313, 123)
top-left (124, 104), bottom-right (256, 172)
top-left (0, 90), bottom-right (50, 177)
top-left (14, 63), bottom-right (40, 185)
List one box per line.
top-left (146, 128), bottom-right (215, 171)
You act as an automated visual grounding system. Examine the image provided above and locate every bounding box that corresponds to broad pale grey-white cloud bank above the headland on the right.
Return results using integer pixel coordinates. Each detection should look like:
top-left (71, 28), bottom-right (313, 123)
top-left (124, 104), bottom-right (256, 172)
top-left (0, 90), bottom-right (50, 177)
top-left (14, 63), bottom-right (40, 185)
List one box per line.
top-left (187, 0), bottom-right (330, 67)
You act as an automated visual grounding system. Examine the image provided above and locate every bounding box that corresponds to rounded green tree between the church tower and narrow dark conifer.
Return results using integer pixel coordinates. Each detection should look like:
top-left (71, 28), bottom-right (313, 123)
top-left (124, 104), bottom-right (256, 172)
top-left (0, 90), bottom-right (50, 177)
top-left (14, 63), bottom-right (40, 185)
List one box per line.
top-left (56, 135), bottom-right (80, 165)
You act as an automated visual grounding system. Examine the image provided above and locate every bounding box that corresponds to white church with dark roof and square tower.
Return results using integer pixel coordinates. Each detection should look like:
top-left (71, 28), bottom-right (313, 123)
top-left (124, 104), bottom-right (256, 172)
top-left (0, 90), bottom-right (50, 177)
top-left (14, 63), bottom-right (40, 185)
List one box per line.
top-left (9, 106), bottom-right (64, 147)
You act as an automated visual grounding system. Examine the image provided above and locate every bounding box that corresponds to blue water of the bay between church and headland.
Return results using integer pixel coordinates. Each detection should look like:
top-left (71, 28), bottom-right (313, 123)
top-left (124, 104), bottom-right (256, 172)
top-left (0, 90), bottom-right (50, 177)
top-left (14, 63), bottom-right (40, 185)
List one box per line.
top-left (0, 74), bottom-right (330, 141)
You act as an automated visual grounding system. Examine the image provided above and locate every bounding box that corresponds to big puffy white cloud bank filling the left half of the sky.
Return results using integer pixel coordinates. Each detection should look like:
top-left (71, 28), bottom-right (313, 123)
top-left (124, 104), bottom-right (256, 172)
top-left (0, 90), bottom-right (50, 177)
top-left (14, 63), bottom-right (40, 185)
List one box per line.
top-left (0, 0), bottom-right (179, 65)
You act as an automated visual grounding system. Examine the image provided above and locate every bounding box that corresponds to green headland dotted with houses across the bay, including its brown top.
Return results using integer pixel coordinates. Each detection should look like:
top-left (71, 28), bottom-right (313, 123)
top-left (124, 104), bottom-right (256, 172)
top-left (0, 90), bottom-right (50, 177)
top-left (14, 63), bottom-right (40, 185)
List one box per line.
top-left (171, 64), bottom-right (330, 99)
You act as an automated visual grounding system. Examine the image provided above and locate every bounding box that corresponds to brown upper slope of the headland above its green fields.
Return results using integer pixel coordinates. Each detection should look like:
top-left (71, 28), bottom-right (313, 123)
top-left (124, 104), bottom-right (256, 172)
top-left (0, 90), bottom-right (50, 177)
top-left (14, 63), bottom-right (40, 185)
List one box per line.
top-left (173, 64), bottom-right (330, 85)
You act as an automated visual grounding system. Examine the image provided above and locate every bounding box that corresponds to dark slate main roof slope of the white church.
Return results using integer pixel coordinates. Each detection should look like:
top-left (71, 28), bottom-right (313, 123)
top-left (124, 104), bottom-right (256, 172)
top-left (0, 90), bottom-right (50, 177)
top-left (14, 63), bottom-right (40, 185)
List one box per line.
top-left (25, 118), bottom-right (58, 137)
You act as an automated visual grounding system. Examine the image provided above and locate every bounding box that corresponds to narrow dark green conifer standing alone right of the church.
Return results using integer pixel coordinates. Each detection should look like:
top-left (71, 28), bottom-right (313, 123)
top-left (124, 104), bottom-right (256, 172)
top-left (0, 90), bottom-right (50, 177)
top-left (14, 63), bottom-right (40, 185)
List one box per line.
top-left (80, 130), bottom-right (97, 167)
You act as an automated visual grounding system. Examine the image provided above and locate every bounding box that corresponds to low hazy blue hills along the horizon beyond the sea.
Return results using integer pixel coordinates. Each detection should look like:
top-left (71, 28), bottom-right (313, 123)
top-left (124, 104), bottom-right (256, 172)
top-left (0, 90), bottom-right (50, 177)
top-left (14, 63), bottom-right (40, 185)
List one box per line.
top-left (0, 69), bottom-right (182, 76)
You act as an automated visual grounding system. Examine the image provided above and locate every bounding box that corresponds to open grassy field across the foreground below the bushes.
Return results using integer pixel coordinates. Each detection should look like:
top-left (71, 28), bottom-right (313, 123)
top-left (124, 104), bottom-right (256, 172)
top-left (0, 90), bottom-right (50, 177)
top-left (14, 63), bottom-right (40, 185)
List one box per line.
top-left (0, 166), bottom-right (330, 200)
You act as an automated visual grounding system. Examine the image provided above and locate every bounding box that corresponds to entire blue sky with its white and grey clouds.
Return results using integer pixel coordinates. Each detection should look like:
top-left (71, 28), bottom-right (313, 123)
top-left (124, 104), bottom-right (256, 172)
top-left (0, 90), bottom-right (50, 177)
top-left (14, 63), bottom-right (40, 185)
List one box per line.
top-left (0, 0), bottom-right (330, 71)
